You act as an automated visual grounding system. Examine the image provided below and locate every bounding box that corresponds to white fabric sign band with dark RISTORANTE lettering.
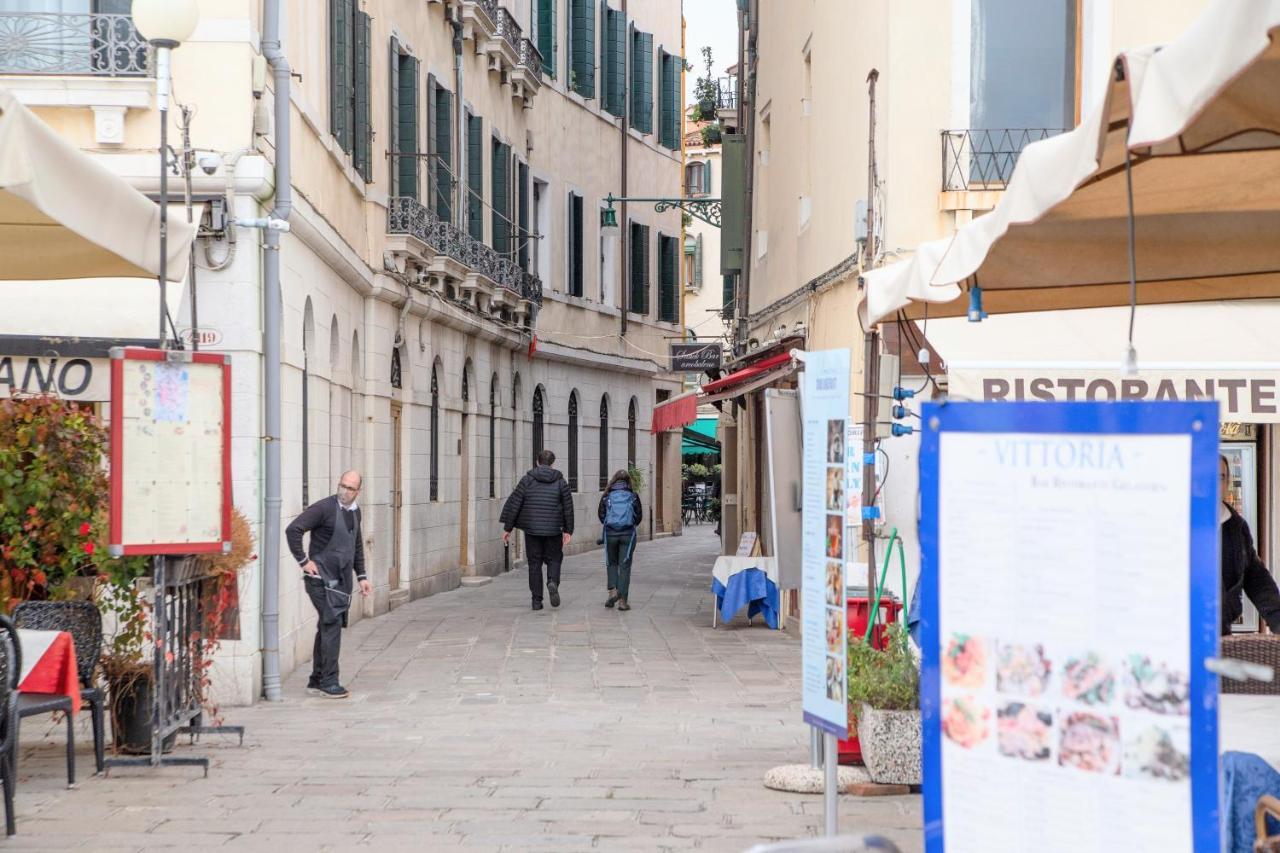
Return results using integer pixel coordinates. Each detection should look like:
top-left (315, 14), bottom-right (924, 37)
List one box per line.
top-left (947, 364), bottom-right (1280, 424)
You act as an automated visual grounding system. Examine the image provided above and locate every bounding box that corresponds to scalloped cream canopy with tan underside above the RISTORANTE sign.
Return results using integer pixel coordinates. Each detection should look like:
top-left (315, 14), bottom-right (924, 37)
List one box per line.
top-left (860, 0), bottom-right (1280, 323)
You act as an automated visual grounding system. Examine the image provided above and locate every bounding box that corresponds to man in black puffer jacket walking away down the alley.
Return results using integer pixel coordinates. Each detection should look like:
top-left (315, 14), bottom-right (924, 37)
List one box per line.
top-left (500, 450), bottom-right (573, 610)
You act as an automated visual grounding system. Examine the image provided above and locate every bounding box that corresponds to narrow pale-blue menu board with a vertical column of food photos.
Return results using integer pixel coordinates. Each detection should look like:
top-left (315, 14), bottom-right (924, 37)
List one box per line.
top-left (800, 350), bottom-right (859, 738)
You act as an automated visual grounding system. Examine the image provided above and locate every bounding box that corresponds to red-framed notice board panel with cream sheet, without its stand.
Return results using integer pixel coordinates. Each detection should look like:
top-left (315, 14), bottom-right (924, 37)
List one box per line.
top-left (109, 347), bottom-right (232, 557)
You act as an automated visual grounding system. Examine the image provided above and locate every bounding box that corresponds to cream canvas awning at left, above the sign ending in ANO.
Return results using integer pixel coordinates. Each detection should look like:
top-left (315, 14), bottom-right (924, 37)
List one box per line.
top-left (0, 90), bottom-right (196, 282)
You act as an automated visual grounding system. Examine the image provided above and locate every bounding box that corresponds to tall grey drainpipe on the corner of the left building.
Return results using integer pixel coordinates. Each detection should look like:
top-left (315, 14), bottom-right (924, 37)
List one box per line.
top-left (262, 0), bottom-right (295, 702)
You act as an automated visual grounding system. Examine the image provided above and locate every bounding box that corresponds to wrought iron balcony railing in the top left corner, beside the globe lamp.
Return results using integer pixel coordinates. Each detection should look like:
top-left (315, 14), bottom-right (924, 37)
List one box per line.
top-left (0, 12), bottom-right (151, 77)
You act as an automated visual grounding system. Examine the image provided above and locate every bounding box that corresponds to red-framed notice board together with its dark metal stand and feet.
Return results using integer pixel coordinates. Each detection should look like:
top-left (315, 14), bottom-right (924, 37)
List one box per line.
top-left (105, 347), bottom-right (244, 776)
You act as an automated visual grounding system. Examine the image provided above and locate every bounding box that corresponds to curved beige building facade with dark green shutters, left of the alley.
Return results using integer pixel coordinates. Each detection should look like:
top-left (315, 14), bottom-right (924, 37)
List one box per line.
top-left (0, 0), bottom-right (682, 703)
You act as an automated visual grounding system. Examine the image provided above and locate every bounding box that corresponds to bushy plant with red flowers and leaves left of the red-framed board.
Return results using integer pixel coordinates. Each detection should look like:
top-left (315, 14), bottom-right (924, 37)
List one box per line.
top-left (0, 396), bottom-right (146, 611)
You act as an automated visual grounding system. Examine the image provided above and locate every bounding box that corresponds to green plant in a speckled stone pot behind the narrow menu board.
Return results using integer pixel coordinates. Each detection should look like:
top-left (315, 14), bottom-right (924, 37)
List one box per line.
top-left (849, 624), bottom-right (920, 785)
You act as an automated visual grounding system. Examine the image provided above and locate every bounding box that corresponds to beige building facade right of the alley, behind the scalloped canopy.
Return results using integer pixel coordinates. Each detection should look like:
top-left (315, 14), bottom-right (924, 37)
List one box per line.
top-left (723, 0), bottom-right (1206, 591)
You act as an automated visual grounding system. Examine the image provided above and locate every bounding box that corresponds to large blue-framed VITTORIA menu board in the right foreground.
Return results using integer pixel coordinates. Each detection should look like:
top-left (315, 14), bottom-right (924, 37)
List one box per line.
top-left (920, 402), bottom-right (1220, 853)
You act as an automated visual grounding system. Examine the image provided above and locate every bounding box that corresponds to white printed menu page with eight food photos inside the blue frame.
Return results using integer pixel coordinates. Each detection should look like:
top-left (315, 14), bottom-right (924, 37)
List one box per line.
top-left (938, 432), bottom-right (1192, 853)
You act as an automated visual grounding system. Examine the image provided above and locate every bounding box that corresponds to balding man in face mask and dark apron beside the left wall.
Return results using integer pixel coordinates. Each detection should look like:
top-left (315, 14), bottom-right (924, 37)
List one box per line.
top-left (284, 471), bottom-right (374, 699)
